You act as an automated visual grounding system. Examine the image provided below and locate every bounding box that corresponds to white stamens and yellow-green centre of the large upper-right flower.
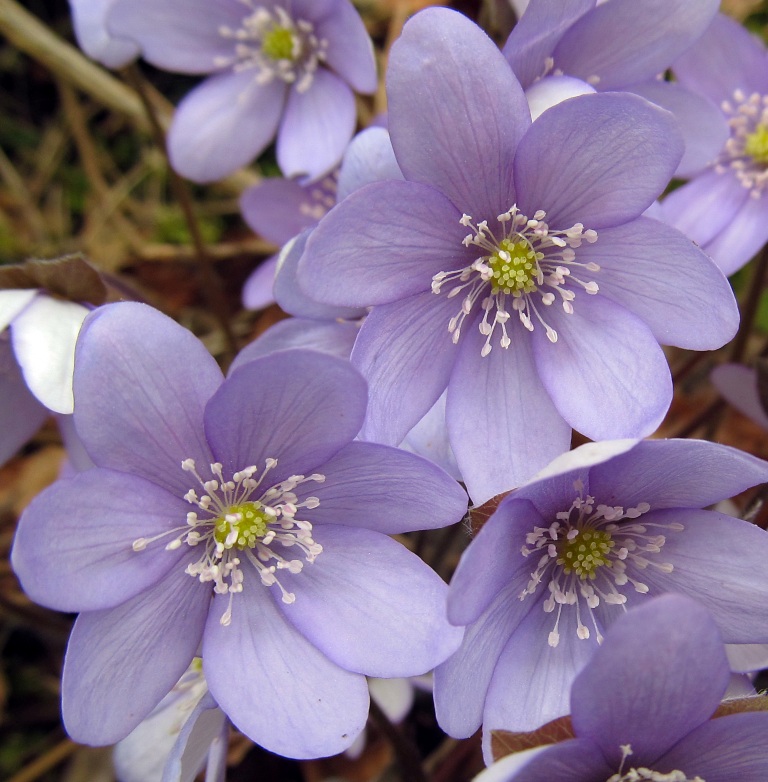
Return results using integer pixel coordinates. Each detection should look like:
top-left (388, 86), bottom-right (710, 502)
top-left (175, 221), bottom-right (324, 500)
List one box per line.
top-left (432, 205), bottom-right (600, 356)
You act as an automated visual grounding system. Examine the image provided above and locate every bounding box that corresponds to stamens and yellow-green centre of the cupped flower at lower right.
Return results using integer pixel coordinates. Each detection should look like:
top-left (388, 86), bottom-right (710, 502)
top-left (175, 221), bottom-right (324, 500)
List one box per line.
top-left (520, 480), bottom-right (683, 647)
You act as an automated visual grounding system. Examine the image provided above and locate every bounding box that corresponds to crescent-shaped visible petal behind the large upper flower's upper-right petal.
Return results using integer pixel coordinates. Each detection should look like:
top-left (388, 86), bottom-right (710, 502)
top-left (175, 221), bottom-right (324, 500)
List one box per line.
top-left (631, 79), bottom-right (730, 178)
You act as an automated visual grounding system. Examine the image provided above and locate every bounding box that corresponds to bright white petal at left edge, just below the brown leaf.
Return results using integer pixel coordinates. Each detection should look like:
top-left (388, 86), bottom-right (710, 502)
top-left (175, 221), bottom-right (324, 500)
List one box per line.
top-left (11, 296), bottom-right (88, 414)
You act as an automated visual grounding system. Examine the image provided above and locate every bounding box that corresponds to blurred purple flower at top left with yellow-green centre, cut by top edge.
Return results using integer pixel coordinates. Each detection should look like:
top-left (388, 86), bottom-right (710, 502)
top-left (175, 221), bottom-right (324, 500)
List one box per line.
top-left (109, 0), bottom-right (376, 182)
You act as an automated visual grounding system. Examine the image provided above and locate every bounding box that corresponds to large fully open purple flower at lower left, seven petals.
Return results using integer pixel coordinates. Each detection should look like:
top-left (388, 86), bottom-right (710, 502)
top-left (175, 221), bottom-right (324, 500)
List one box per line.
top-left (12, 303), bottom-right (466, 757)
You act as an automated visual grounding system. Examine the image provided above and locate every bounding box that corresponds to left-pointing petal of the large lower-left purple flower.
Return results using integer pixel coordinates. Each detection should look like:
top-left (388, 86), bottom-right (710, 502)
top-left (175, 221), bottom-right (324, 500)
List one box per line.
top-left (12, 467), bottom-right (188, 611)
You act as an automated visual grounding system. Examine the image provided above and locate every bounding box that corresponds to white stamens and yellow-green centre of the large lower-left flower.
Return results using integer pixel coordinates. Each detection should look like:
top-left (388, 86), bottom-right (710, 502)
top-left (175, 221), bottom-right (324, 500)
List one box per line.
top-left (133, 459), bottom-right (325, 625)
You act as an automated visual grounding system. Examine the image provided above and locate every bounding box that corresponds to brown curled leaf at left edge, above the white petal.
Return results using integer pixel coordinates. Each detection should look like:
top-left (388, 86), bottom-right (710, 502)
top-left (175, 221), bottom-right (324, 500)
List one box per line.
top-left (0, 253), bottom-right (107, 304)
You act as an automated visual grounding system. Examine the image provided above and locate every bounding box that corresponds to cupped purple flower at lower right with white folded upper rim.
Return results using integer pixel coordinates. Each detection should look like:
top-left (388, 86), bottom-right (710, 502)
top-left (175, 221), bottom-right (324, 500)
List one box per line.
top-left (435, 440), bottom-right (768, 752)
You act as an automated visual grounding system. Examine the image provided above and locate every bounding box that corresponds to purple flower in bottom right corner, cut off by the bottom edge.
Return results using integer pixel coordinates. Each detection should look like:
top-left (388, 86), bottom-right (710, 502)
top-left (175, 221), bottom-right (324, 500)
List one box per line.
top-left (476, 595), bottom-right (768, 782)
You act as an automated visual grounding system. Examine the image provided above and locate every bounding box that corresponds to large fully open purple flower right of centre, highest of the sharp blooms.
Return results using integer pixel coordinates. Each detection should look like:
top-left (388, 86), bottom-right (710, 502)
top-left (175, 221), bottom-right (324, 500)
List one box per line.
top-left (298, 9), bottom-right (738, 502)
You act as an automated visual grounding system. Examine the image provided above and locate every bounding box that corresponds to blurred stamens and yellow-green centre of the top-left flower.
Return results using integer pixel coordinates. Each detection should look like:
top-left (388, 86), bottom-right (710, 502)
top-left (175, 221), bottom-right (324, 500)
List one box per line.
top-left (214, 5), bottom-right (328, 92)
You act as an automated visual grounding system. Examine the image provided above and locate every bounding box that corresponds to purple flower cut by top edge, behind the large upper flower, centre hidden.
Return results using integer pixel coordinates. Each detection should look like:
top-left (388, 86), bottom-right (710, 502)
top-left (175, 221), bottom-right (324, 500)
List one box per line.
top-left (504, 0), bottom-right (727, 176)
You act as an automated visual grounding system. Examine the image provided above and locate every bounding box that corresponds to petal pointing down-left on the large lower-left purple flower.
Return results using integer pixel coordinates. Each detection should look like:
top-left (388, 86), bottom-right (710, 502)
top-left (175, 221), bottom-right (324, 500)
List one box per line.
top-left (61, 566), bottom-right (211, 746)
